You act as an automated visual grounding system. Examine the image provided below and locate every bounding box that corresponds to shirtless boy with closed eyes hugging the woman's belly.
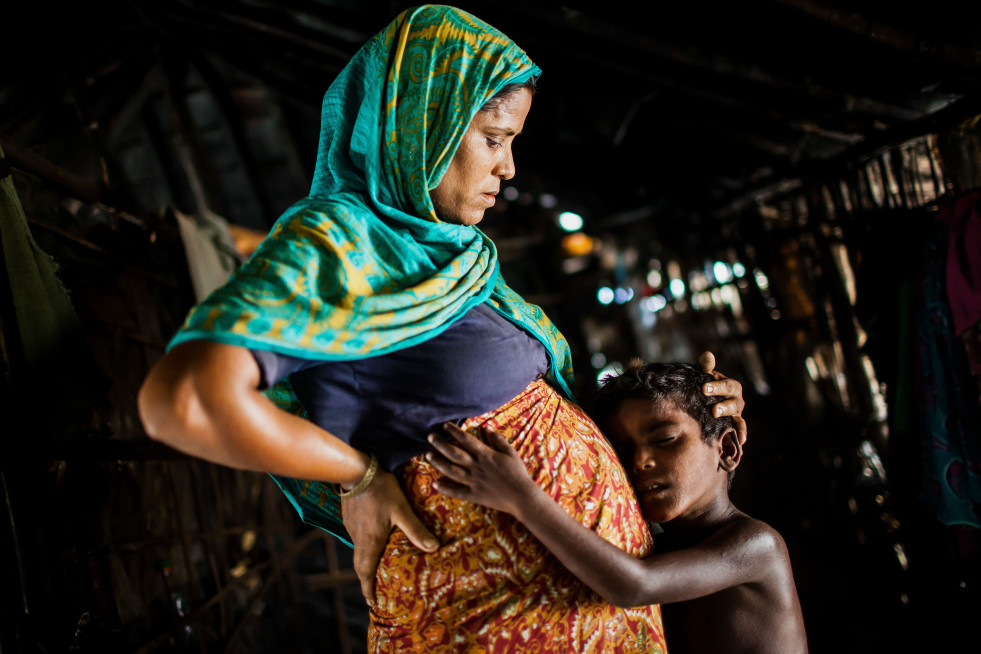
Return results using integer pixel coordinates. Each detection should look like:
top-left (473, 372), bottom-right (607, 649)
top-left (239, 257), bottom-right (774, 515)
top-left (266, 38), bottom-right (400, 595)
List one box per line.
top-left (427, 363), bottom-right (807, 654)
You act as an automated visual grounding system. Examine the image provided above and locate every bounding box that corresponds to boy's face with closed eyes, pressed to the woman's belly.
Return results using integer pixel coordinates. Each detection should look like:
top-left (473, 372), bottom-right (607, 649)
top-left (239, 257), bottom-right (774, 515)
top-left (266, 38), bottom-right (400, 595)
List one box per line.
top-left (606, 399), bottom-right (727, 523)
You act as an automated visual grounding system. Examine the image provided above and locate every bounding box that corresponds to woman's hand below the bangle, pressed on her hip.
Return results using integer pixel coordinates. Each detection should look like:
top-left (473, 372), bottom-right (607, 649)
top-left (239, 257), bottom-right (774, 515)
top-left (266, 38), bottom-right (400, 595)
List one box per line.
top-left (341, 471), bottom-right (439, 607)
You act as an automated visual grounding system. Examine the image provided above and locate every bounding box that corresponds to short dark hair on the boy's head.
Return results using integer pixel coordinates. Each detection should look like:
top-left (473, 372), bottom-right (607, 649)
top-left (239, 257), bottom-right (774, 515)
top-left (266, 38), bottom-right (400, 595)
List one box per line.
top-left (590, 359), bottom-right (735, 442)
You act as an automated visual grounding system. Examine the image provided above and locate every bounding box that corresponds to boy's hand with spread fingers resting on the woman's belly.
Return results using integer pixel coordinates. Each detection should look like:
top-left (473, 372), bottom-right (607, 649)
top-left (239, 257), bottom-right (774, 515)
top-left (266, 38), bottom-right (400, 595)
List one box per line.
top-left (426, 423), bottom-right (537, 515)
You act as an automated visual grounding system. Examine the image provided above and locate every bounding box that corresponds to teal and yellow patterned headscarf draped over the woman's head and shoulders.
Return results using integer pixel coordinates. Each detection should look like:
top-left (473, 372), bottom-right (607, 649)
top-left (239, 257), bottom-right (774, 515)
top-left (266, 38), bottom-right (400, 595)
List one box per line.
top-left (170, 5), bottom-right (572, 544)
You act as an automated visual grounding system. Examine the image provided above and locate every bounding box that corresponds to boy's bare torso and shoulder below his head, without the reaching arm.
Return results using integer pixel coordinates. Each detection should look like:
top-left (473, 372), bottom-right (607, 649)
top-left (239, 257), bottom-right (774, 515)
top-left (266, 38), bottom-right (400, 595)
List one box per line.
top-left (655, 513), bottom-right (807, 654)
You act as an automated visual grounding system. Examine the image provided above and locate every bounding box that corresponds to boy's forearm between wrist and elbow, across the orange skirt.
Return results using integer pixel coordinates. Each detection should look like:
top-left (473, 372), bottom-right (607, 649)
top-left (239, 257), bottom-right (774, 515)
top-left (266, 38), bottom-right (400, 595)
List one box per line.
top-left (515, 485), bottom-right (650, 607)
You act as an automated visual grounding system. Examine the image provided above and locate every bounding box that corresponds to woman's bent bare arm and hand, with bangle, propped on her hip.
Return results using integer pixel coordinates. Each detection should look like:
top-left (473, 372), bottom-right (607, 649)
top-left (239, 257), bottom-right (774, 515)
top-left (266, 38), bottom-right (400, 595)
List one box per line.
top-left (138, 340), bottom-right (439, 604)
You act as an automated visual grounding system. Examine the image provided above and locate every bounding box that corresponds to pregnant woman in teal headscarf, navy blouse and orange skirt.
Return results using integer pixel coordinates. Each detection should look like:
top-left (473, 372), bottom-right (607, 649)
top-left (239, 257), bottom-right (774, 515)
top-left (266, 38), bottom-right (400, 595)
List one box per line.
top-left (139, 6), bottom-right (742, 653)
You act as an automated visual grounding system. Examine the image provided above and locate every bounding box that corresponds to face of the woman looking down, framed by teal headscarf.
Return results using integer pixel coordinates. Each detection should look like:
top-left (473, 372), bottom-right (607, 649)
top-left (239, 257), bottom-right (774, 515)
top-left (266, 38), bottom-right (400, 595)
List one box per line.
top-left (429, 89), bottom-right (531, 225)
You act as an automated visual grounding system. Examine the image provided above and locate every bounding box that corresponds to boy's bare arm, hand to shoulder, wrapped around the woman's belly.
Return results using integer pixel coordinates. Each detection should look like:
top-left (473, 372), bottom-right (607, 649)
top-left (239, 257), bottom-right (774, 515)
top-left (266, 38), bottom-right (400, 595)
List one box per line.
top-left (427, 425), bottom-right (783, 607)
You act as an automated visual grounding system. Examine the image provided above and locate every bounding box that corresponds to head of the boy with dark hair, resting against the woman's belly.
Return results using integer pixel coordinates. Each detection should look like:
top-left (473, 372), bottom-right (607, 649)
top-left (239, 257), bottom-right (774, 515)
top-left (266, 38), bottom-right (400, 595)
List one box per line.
top-left (592, 362), bottom-right (742, 522)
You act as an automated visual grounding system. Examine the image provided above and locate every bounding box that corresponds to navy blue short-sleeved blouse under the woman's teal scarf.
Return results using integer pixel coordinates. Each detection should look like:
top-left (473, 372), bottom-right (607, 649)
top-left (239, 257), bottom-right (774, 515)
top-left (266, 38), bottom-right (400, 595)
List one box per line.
top-left (252, 304), bottom-right (548, 470)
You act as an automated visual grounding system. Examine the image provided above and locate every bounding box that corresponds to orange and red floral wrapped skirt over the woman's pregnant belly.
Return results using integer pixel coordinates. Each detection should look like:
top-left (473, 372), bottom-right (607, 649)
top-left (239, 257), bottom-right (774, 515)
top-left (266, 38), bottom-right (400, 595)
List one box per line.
top-left (368, 381), bottom-right (667, 654)
